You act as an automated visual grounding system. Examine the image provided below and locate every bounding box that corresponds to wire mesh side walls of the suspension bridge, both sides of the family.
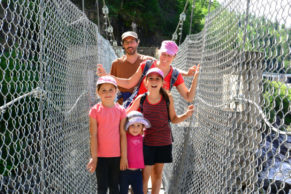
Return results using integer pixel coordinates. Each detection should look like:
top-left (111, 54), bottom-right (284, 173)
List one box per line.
top-left (0, 0), bottom-right (291, 194)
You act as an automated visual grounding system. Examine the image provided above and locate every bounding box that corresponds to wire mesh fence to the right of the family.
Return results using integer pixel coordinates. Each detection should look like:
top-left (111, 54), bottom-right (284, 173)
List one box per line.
top-left (164, 0), bottom-right (291, 194)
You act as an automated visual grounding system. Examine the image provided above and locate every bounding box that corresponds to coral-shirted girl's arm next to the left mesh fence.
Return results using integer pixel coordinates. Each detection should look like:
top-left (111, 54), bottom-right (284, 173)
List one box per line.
top-left (87, 117), bottom-right (97, 173)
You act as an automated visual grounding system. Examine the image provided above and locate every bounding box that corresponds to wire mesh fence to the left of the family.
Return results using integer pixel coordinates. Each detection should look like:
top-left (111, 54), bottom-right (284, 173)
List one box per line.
top-left (0, 0), bottom-right (122, 193)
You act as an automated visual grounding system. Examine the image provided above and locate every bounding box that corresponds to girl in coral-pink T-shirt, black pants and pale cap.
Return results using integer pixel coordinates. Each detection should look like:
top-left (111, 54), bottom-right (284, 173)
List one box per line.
top-left (87, 76), bottom-right (127, 194)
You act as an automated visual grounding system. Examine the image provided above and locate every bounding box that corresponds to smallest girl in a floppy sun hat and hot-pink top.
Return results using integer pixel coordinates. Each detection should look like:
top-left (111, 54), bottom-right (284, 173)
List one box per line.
top-left (120, 111), bottom-right (150, 194)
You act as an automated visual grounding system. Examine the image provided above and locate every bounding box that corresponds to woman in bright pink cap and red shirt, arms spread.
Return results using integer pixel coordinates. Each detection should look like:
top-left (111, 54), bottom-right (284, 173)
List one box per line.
top-left (97, 40), bottom-right (199, 102)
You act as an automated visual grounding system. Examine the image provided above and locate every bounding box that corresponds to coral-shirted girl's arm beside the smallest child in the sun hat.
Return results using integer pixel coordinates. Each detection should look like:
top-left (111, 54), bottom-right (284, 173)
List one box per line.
top-left (119, 118), bottom-right (128, 170)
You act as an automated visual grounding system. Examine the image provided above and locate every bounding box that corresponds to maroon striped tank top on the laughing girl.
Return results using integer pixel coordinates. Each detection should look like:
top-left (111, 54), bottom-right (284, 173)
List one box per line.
top-left (143, 94), bottom-right (172, 146)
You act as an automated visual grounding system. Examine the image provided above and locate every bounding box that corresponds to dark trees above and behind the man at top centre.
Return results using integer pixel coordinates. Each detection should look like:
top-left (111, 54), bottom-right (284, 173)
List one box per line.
top-left (73, 0), bottom-right (218, 46)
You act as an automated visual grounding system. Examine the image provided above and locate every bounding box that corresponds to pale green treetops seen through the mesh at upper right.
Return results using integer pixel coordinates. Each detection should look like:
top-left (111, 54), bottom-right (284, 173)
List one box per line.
top-left (207, 7), bottom-right (291, 73)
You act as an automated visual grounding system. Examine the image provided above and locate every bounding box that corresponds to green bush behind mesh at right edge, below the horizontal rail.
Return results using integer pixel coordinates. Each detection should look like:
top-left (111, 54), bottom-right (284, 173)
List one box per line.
top-left (263, 80), bottom-right (291, 128)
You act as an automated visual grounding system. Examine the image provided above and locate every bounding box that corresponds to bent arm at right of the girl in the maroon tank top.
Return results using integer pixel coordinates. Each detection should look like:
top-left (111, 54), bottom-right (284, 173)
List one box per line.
top-left (169, 95), bottom-right (194, 123)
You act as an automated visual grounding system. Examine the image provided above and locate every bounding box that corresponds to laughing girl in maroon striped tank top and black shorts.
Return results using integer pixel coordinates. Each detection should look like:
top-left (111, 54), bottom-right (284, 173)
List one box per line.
top-left (127, 68), bottom-right (194, 193)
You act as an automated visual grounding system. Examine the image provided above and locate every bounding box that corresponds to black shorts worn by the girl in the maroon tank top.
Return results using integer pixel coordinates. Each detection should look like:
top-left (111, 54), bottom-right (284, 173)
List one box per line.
top-left (143, 145), bottom-right (173, 165)
